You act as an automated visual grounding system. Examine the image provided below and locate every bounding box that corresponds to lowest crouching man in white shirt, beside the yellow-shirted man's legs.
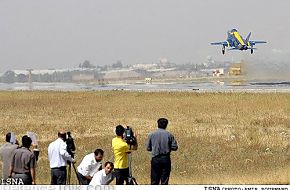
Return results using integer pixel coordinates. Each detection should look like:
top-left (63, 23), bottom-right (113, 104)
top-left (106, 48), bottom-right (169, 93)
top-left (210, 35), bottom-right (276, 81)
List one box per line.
top-left (89, 162), bottom-right (114, 186)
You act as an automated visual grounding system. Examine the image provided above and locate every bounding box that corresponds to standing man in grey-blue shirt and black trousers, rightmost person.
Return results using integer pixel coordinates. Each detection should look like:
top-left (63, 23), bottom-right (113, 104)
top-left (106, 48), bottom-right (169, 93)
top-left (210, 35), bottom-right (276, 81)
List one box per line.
top-left (147, 118), bottom-right (178, 185)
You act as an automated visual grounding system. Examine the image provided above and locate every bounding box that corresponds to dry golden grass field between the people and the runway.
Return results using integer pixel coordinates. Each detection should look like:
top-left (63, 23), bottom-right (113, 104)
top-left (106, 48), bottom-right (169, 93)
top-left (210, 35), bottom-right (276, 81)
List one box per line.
top-left (0, 91), bottom-right (290, 184)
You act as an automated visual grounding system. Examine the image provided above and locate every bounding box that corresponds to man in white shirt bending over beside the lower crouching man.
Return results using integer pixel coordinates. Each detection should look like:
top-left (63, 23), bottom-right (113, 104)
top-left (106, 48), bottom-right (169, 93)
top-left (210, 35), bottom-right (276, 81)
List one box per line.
top-left (77, 149), bottom-right (104, 185)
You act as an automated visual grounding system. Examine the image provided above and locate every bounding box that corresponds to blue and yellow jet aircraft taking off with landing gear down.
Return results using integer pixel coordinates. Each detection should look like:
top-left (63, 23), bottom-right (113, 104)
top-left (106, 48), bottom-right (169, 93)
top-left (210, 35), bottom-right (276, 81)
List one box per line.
top-left (210, 29), bottom-right (267, 54)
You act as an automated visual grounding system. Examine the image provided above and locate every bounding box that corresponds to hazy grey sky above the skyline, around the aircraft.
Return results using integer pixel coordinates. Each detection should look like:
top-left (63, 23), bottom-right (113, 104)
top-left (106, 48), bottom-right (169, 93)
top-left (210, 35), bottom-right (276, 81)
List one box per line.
top-left (0, 0), bottom-right (290, 72)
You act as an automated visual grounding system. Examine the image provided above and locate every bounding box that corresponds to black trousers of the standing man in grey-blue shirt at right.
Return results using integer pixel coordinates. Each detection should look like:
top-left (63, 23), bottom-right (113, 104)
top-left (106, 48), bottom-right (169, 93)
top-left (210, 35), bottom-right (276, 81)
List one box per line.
top-left (151, 155), bottom-right (171, 185)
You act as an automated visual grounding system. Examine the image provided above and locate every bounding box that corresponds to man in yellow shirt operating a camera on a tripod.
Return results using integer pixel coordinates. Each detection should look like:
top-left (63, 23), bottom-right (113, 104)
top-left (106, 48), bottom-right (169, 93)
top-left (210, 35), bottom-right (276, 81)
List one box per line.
top-left (112, 125), bottom-right (138, 185)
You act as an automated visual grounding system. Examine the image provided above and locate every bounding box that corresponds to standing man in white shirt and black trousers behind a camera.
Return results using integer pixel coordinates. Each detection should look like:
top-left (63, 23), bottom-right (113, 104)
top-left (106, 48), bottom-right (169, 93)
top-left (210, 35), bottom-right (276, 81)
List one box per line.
top-left (48, 131), bottom-right (75, 185)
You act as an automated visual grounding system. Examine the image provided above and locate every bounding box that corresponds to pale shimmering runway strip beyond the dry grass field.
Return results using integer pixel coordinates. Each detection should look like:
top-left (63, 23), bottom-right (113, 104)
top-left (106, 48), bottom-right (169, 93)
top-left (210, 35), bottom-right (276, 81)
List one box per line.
top-left (0, 80), bottom-right (290, 93)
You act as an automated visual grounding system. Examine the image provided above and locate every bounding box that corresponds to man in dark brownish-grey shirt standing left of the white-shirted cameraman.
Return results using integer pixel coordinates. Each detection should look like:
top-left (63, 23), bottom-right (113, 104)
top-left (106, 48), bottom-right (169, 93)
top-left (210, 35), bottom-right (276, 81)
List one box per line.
top-left (9, 135), bottom-right (36, 185)
